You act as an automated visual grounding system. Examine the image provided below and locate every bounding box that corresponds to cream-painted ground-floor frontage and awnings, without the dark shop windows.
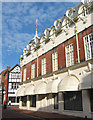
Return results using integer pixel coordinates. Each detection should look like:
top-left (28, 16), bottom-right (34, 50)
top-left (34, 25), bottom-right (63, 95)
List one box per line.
top-left (18, 60), bottom-right (93, 118)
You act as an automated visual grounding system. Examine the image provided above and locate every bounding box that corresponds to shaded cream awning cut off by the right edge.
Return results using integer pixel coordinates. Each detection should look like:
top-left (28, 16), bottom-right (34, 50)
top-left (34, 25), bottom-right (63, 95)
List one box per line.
top-left (79, 72), bottom-right (93, 89)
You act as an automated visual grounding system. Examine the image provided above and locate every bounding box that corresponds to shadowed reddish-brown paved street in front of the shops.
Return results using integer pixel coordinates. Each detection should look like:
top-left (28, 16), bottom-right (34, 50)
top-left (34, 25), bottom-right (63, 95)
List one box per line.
top-left (2, 106), bottom-right (92, 120)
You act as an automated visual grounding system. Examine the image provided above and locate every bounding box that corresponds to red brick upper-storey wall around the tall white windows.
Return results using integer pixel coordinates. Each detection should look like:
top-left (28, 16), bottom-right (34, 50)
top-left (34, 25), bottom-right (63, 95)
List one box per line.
top-left (22, 26), bottom-right (93, 79)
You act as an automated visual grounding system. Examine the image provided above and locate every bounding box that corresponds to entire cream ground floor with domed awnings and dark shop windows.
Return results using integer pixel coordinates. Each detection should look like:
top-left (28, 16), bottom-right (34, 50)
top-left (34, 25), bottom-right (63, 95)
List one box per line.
top-left (16, 63), bottom-right (93, 118)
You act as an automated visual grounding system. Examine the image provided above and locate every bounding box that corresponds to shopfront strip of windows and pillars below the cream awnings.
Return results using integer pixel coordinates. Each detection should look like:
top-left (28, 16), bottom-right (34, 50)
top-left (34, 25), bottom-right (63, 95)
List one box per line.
top-left (19, 89), bottom-right (93, 118)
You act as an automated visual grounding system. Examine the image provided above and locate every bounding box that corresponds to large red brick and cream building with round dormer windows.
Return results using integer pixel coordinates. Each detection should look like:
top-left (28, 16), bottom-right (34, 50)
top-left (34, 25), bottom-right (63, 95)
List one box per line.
top-left (16, 2), bottom-right (93, 118)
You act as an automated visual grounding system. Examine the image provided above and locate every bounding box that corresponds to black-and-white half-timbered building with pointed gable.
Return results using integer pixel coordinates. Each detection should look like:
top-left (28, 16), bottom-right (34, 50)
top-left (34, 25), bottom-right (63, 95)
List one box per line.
top-left (8, 64), bottom-right (20, 105)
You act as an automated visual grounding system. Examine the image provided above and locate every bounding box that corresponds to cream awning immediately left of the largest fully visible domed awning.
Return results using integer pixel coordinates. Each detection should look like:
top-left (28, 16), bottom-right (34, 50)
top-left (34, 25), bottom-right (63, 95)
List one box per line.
top-left (46, 79), bottom-right (59, 93)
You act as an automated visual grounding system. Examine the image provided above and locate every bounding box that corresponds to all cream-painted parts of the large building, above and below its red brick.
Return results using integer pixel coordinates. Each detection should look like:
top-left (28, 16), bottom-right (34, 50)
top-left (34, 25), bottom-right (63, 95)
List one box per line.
top-left (16, 3), bottom-right (93, 118)
